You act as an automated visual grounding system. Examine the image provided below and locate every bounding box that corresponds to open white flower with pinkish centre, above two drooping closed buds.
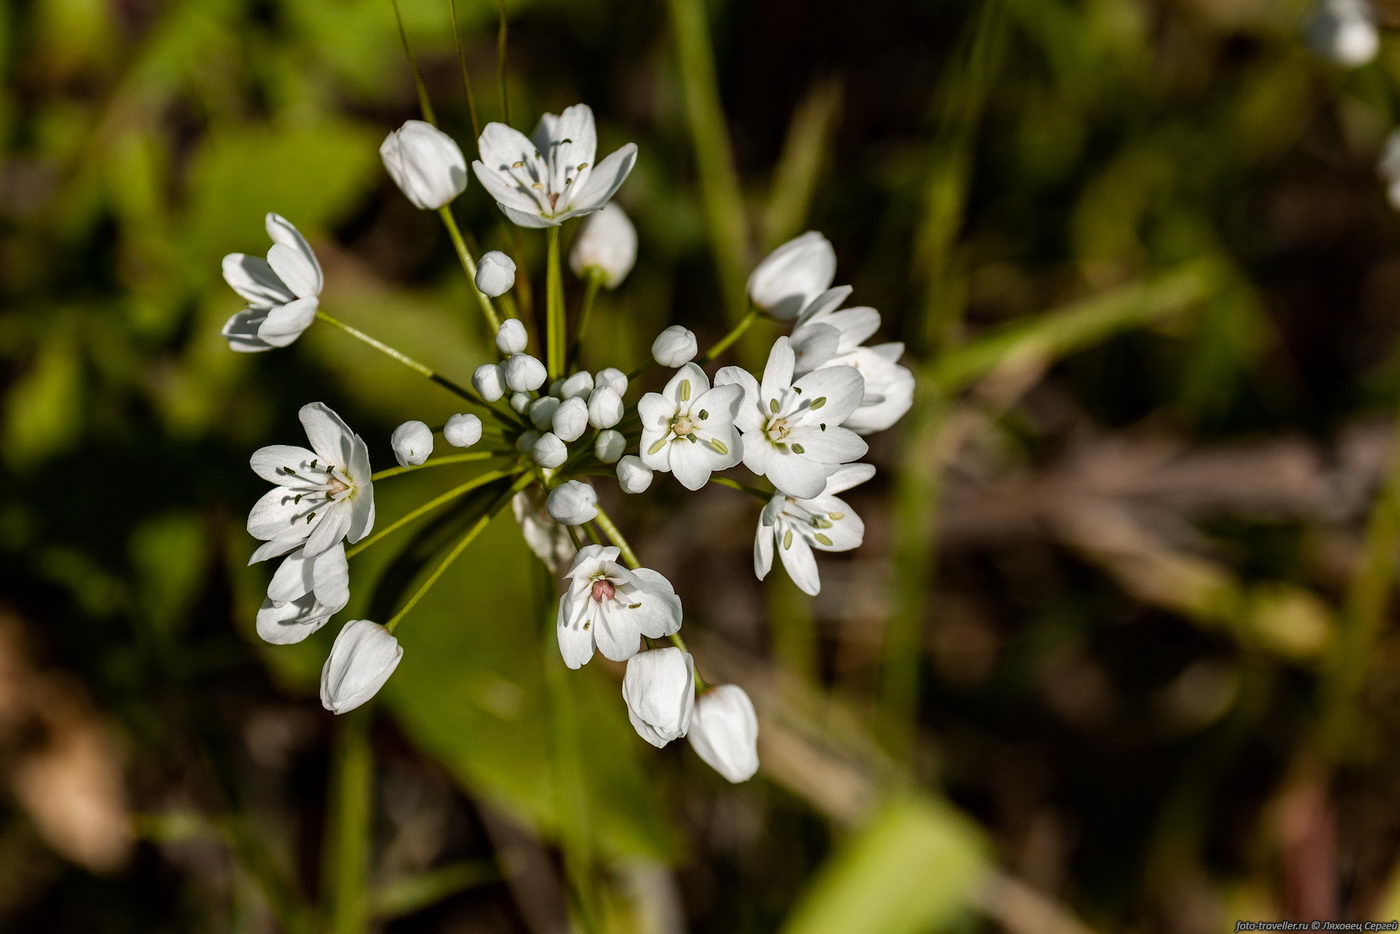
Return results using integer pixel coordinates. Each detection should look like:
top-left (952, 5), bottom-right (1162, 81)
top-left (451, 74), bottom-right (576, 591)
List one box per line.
top-left (559, 545), bottom-right (680, 668)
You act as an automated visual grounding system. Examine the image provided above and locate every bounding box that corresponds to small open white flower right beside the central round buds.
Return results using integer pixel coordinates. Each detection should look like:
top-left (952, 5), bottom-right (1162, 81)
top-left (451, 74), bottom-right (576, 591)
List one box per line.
top-left (637, 363), bottom-right (752, 490)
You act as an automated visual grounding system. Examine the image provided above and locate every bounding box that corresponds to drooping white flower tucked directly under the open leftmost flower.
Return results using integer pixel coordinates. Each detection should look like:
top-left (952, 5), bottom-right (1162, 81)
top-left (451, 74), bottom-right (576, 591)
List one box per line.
top-left (258, 543), bottom-right (350, 646)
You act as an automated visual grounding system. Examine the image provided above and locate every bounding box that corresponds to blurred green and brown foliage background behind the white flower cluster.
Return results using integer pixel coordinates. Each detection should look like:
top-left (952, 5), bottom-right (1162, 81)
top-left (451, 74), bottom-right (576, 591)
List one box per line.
top-left (8, 0), bottom-right (1400, 934)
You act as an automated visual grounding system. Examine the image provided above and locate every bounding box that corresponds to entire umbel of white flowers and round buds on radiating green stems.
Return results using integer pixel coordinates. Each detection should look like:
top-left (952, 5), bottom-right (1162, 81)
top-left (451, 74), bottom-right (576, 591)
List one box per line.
top-left (224, 105), bottom-right (914, 781)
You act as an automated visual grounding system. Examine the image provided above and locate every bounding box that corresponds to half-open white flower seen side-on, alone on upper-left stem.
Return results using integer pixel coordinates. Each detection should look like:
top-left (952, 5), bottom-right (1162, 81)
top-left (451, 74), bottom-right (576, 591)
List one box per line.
top-left (223, 214), bottom-right (323, 353)
